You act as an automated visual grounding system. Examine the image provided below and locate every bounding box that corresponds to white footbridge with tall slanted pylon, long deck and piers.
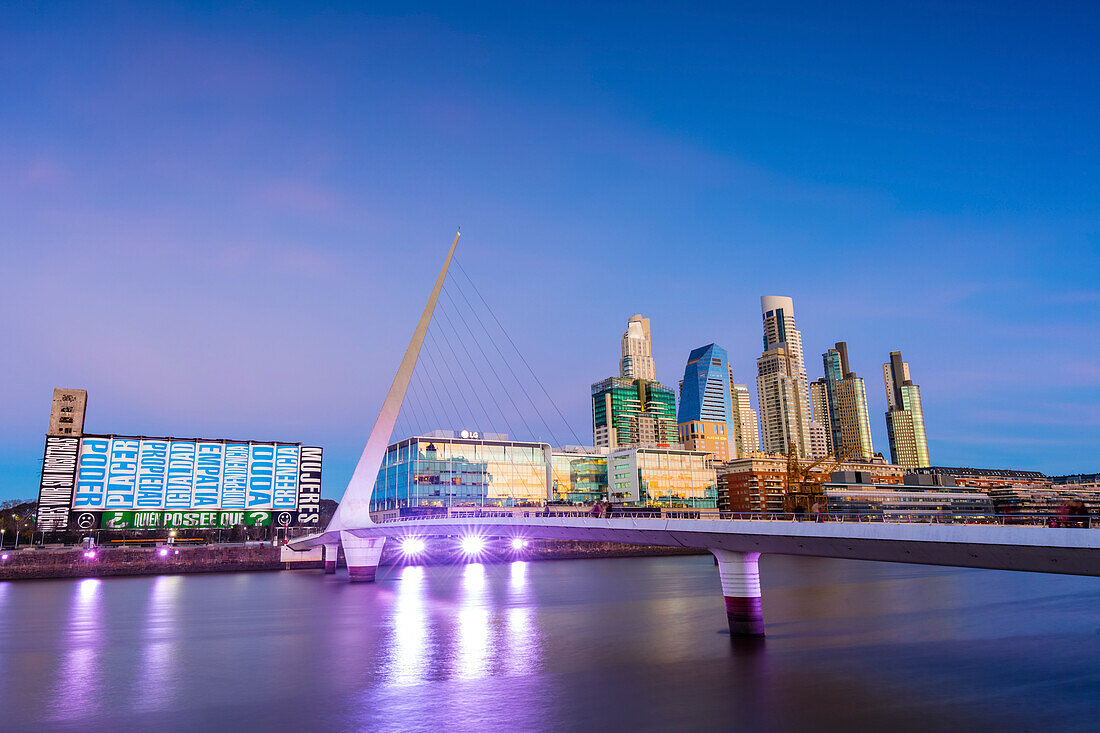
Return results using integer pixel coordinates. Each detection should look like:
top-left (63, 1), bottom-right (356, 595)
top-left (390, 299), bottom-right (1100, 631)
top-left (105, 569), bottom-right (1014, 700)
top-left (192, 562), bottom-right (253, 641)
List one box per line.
top-left (288, 233), bottom-right (1100, 636)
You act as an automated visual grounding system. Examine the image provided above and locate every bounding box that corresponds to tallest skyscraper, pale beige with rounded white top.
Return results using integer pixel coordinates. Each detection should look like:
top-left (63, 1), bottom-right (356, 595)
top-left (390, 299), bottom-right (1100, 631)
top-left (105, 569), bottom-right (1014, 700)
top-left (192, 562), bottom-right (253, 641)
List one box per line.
top-left (757, 295), bottom-right (813, 458)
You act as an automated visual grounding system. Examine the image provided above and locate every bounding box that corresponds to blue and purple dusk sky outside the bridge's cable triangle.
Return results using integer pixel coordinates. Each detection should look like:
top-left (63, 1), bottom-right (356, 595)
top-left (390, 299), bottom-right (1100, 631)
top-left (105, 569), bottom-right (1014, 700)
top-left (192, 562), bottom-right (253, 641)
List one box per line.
top-left (0, 1), bottom-right (1100, 500)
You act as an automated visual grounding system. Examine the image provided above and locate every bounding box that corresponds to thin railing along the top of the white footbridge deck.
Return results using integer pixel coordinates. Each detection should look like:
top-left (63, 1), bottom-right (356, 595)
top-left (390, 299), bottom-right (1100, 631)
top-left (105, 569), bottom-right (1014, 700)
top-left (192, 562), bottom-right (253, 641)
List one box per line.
top-left (375, 507), bottom-right (1100, 529)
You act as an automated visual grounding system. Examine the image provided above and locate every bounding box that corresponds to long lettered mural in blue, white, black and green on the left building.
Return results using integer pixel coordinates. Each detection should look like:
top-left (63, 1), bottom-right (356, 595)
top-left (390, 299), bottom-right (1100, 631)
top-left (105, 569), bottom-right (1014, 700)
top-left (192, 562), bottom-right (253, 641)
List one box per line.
top-left (39, 435), bottom-right (321, 530)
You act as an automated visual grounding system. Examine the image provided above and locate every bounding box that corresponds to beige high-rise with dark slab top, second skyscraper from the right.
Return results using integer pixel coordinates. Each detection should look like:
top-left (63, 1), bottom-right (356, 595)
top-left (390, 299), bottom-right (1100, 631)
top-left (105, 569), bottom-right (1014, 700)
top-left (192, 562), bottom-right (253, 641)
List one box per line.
top-left (810, 341), bottom-right (875, 461)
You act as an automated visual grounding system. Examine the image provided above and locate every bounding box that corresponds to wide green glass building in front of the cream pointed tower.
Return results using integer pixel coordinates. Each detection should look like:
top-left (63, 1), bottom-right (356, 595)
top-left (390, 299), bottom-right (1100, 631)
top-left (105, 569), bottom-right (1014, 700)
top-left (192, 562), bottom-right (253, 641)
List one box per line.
top-left (592, 376), bottom-right (679, 450)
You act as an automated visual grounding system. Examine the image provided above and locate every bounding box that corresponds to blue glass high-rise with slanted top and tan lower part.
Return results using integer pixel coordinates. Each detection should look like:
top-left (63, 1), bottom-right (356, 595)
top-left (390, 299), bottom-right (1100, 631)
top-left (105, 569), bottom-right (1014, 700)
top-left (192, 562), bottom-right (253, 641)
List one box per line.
top-left (677, 343), bottom-right (734, 461)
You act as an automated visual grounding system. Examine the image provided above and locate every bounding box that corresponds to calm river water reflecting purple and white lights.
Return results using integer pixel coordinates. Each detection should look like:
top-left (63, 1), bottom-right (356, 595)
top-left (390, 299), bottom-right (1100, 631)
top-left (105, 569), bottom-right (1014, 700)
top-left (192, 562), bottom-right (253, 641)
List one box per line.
top-left (0, 556), bottom-right (1100, 733)
